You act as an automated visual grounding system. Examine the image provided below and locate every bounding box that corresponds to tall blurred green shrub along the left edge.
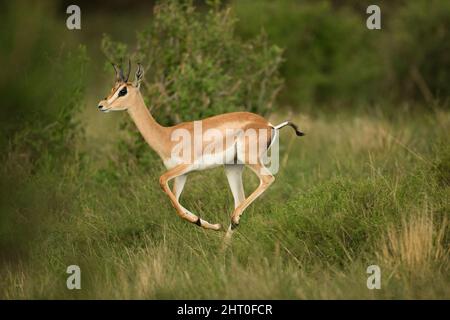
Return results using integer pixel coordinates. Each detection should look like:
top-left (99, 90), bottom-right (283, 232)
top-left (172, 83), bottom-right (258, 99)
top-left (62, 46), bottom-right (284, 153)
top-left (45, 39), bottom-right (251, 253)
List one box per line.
top-left (0, 1), bottom-right (87, 268)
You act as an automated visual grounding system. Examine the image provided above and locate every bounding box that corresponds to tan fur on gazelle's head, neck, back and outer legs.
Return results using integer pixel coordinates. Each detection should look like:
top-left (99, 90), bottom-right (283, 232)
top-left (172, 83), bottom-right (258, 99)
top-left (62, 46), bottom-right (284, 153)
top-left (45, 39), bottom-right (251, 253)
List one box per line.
top-left (99, 82), bottom-right (275, 237)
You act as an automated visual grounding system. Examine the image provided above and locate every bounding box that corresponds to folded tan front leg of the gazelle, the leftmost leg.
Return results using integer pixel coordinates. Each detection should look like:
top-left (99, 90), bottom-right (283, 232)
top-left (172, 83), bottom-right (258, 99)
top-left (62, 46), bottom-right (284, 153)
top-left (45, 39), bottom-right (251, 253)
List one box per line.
top-left (159, 165), bottom-right (220, 230)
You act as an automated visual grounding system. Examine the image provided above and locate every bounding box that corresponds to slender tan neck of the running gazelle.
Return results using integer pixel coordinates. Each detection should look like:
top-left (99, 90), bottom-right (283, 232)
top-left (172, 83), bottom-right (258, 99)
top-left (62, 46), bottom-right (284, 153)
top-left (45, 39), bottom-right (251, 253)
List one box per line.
top-left (128, 94), bottom-right (167, 159)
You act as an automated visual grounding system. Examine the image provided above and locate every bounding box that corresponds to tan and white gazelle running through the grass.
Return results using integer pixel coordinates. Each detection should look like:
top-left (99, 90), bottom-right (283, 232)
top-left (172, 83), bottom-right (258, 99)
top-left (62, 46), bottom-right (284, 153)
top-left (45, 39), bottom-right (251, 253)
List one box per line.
top-left (98, 63), bottom-right (303, 238)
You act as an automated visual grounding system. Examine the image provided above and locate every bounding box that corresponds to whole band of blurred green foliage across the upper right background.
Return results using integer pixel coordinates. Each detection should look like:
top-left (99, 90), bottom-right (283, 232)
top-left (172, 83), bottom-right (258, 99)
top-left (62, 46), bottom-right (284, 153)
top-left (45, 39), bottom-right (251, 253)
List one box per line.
top-left (233, 0), bottom-right (450, 110)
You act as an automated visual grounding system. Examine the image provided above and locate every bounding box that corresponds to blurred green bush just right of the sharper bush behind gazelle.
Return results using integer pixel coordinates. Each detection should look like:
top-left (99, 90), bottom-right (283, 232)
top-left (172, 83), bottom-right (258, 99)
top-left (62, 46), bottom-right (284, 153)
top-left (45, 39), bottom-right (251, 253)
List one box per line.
top-left (234, 1), bottom-right (380, 106)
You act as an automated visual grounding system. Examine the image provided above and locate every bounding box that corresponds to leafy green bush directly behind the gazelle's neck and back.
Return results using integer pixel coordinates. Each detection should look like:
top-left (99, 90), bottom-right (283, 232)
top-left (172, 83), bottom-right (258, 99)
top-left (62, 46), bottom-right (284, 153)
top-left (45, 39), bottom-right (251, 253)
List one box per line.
top-left (102, 1), bottom-right (282, 166)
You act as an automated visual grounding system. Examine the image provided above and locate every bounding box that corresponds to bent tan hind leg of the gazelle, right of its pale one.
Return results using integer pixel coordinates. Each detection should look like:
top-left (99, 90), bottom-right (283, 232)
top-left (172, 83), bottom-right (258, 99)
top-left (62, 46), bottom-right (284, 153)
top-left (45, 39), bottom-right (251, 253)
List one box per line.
top-left (230, 163), bottom-right (275, 230)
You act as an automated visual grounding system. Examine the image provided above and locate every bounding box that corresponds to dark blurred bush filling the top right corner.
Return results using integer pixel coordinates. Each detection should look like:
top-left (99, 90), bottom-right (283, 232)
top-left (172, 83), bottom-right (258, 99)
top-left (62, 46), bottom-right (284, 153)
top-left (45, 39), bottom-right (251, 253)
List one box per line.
top-left (385, 0), bottom-right (450, 102)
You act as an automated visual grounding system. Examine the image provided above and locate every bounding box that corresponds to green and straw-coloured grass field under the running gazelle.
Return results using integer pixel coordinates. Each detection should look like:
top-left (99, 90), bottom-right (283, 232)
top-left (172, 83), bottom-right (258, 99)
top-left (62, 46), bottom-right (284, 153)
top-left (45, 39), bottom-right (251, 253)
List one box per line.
top-left (0, 111), bottom-right (450, 299)
